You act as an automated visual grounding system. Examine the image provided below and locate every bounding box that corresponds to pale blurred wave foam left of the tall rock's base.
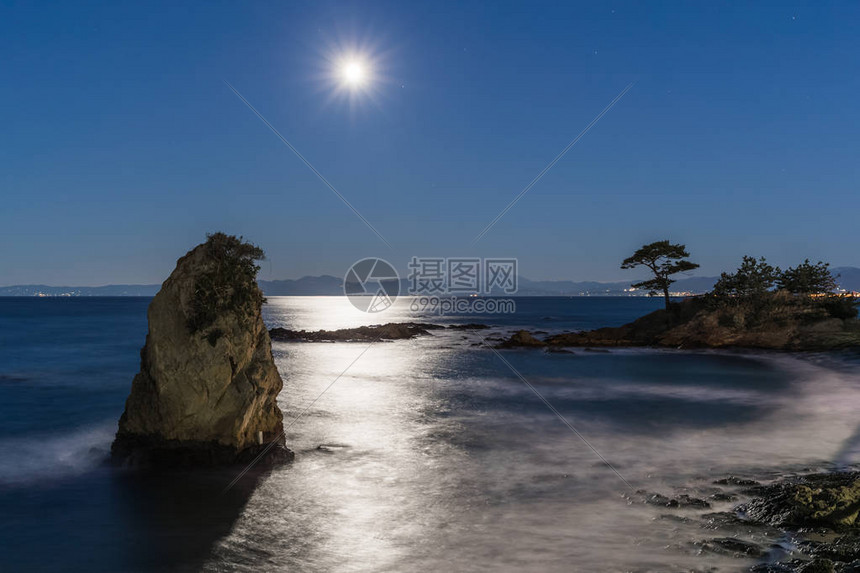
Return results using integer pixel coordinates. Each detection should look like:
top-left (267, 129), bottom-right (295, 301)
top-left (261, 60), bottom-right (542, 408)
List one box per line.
top-left (0, 424), bottom-right (116, 486)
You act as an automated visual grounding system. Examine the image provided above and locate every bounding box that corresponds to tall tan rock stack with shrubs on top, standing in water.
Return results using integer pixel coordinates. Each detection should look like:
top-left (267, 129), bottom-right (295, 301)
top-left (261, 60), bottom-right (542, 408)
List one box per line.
top-left (112, 233), bottom-right (291, 466)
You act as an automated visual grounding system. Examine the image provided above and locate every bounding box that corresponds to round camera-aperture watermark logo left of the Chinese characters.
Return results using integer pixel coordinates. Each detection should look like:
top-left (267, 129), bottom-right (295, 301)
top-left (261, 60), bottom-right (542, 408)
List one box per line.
top-left (343, 257), bottom-right (400, 312)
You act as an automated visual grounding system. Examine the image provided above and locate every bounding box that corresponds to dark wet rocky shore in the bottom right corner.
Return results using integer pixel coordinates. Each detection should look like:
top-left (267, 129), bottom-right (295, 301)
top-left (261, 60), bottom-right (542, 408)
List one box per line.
top-left (656, 472), bottom-right (860, 573)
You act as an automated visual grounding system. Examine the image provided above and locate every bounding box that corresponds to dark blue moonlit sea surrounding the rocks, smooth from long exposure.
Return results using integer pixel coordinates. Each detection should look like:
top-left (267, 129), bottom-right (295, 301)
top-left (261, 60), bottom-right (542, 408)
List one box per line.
top-left (0, 297), bottom-right (860, 572)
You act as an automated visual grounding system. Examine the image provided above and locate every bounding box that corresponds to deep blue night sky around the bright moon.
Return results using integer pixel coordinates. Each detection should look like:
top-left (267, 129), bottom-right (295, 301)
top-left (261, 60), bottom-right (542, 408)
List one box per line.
top-left (0, 0), bottom-right (860, 285)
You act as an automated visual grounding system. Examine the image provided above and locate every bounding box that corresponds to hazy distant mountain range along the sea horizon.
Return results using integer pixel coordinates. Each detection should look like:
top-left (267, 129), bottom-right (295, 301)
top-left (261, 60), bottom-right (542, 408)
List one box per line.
top-left (0, 267), bottom-right (860, 296)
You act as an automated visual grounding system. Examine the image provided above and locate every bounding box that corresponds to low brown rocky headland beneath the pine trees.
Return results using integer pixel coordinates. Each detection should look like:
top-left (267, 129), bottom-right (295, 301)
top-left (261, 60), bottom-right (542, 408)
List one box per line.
top-left (494, 294), bottom-right (860, 351)
